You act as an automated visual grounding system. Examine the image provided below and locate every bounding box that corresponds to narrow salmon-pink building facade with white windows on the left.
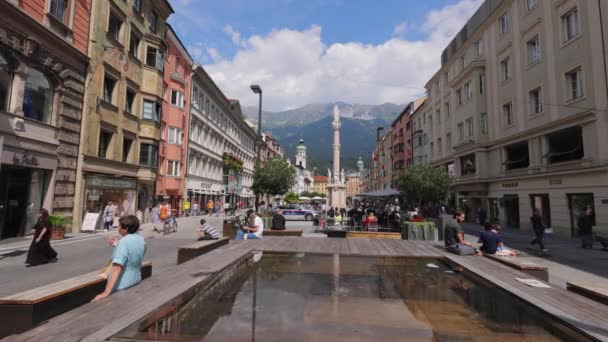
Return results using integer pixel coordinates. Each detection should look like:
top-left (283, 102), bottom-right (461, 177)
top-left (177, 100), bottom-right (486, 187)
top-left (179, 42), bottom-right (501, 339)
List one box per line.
top-left (156, 27), bottom-right (193, 212)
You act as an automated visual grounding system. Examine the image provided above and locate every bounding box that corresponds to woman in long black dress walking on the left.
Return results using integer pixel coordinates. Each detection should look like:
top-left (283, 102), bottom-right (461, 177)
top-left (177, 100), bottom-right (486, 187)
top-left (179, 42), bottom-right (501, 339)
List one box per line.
top-left (25, 209), bottom-right (57, 267)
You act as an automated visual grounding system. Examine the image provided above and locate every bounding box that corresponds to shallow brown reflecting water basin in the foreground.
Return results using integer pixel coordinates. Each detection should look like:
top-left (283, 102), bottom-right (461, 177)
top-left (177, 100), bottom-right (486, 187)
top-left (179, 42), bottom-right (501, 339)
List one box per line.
top-left (113, 254), bottom-right (583, 341)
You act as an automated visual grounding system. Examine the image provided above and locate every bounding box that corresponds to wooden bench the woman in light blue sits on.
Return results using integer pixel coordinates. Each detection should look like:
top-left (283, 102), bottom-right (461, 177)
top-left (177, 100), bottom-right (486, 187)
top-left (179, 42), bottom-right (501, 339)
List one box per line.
top-left (0, 261), bottom-right (152, 338)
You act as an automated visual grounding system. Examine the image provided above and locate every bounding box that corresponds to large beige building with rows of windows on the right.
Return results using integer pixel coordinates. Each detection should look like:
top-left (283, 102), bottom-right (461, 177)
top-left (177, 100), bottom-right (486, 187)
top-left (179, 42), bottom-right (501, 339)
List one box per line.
top-left (425, 0), bottom-right (608, 236)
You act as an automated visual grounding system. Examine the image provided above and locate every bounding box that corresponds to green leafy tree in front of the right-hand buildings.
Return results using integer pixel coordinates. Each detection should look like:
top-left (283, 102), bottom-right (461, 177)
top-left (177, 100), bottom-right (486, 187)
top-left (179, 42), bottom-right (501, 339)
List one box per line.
top-left (396, 165), bottom-right (450, 207)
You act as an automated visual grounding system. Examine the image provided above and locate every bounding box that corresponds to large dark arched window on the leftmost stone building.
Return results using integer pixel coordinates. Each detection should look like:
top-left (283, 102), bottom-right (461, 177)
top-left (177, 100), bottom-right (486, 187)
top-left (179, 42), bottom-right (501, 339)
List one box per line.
top-left (23, 68), bottom-right (53, 123)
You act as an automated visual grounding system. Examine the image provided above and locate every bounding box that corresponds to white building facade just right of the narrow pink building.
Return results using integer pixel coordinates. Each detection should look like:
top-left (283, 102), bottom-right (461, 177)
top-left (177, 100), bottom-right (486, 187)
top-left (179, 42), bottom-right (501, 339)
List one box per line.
top-left (186, 65), bottom-right (257, 207)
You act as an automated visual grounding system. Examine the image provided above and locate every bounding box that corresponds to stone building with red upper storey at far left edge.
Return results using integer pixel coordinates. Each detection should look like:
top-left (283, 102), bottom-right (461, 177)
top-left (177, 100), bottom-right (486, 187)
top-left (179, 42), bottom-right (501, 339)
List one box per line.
top-left (0, 0), bottom-right (91, 239)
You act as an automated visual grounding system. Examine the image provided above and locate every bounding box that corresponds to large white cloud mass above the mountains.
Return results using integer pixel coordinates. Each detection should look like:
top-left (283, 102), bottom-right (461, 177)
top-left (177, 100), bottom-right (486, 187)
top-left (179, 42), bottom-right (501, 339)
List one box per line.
top-left (205, 0), bottom-right (482, 110)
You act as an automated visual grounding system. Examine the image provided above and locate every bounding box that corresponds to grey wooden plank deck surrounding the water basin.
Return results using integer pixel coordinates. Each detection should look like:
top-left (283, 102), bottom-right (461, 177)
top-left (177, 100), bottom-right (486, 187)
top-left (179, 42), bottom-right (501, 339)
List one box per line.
top-left (6, 237), bottom-right (608, 342)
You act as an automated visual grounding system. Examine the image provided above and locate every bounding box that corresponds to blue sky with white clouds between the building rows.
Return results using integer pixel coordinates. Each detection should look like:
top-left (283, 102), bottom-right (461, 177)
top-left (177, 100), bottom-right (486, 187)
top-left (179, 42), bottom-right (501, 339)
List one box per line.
top-left (169, 0), bottom-right (482, 111)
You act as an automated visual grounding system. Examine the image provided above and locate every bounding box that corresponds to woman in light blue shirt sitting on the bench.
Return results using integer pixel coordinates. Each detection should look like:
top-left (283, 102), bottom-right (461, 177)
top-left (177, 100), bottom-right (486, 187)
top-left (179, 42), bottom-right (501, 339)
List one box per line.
top-left (93, 215), bottom-right (146, 301)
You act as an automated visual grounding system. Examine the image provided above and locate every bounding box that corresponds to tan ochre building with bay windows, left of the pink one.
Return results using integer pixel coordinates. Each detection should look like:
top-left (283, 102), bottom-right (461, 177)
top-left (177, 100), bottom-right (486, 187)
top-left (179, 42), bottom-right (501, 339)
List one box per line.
top-left (74, 0), bottom-right (173, 229)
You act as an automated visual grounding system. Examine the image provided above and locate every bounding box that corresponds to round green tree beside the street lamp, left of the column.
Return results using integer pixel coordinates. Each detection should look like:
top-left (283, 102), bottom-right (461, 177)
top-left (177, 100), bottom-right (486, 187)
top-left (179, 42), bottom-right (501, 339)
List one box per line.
top-left (252, 158), bottom-right (296, 196)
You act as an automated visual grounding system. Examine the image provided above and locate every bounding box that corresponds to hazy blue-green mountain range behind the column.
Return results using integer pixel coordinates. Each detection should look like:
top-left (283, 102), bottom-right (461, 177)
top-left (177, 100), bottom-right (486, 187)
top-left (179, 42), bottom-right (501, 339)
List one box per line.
top-left (242, 102), bottom-right (405, 171)
